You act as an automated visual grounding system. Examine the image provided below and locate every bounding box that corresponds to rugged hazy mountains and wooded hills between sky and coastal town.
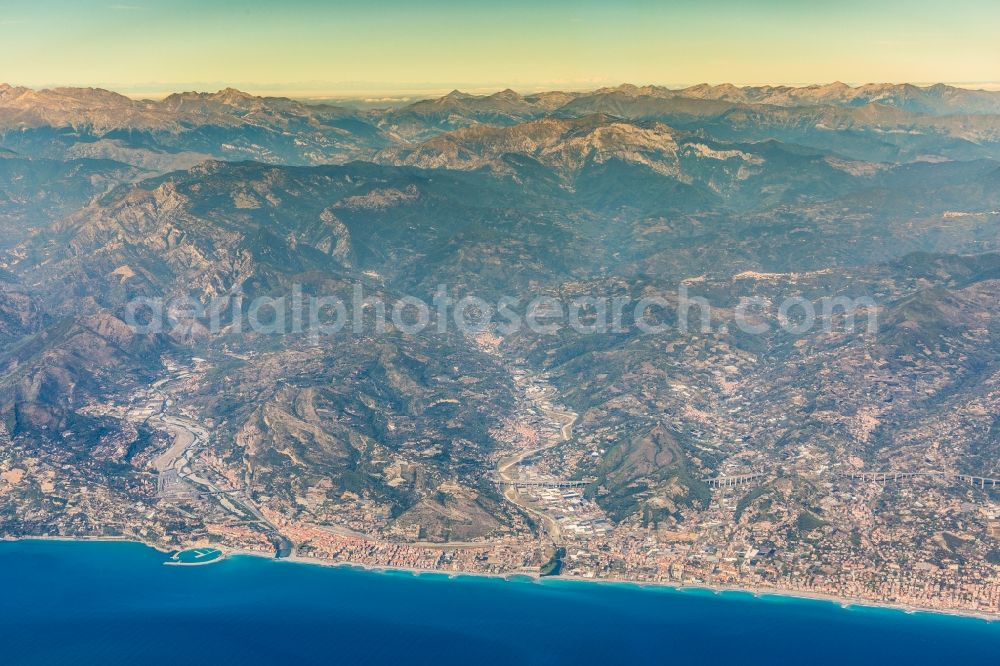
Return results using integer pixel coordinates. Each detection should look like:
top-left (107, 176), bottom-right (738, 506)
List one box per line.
top-left (0, 83), bottom-right (1000, 600)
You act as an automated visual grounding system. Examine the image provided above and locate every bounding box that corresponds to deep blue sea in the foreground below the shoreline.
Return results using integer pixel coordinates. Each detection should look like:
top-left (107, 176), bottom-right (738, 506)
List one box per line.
top-left (0, 541), bottom-right (1000, 666)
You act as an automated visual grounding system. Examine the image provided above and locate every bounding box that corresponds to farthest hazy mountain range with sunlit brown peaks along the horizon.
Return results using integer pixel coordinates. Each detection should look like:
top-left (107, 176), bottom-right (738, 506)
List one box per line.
top-left (0, 84), bottom-right (1000, 169)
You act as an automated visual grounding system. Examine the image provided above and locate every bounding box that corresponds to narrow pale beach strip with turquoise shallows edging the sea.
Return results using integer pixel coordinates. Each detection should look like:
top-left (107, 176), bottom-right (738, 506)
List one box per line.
top-left (0, 535), bottom-right (1000, 624)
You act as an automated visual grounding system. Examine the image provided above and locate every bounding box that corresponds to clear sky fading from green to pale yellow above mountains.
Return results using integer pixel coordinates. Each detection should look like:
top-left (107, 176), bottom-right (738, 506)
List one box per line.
top-left (0, 0), bottom-right (1000, 95)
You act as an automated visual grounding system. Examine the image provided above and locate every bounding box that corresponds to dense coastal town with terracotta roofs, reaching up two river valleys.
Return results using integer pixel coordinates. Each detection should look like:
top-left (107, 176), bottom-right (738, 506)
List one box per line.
top-left (0, 348), bottom-right (1000, 616)
